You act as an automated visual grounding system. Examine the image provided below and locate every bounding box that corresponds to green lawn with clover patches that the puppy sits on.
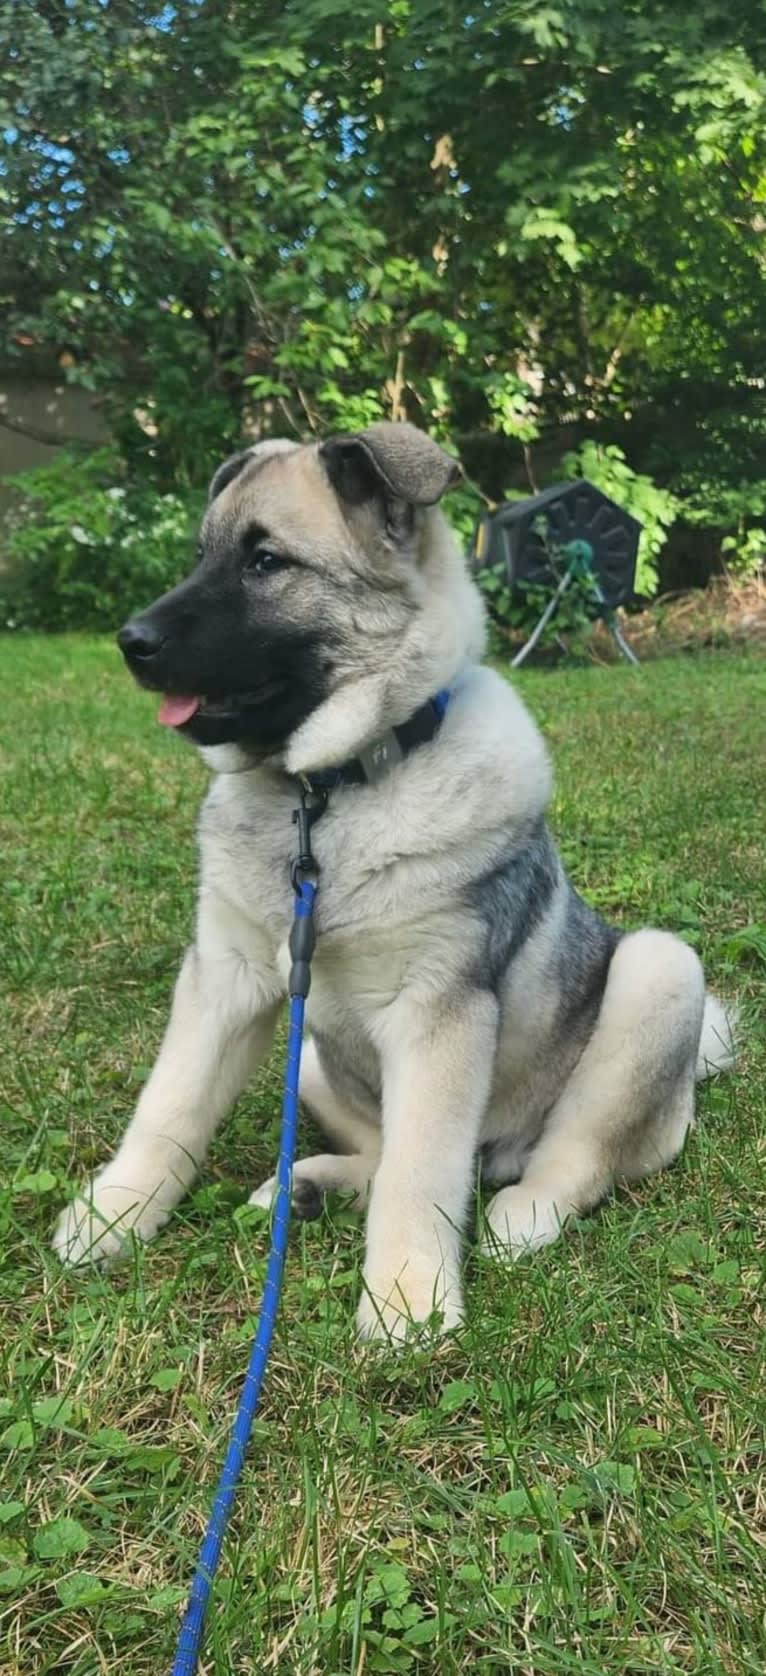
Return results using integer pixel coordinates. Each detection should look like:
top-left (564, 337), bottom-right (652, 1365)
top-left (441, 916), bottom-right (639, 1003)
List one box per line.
top-left (0, 639), bottom-right (766, 1676)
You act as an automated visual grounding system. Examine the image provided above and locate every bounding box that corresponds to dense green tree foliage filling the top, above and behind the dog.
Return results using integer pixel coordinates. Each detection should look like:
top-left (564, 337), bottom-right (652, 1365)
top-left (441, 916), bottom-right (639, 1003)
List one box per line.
top-left (0, 0), bottom-right (766, 616)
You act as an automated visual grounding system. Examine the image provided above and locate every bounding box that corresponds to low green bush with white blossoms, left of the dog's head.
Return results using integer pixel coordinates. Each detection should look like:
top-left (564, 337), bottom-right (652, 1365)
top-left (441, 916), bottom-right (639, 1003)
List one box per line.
top-left (0, 449), bottom-right (201, 630)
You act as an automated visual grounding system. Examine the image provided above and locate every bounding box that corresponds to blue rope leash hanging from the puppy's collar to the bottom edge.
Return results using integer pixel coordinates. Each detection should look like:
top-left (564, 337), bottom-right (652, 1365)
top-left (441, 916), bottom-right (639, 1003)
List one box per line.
top-left (171, 858), bottom-right (320, 1676)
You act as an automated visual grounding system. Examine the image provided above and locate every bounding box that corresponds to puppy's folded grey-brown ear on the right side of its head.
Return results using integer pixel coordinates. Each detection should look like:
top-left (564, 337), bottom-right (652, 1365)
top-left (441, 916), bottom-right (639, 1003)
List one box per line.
top-left (320, 421), bottom-right (461, 506)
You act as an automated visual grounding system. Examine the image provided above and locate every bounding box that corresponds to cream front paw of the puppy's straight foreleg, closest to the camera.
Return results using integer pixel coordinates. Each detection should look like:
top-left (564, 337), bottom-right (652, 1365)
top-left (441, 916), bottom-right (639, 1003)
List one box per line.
top-left (357, 1257), bottom-right (463, 1344)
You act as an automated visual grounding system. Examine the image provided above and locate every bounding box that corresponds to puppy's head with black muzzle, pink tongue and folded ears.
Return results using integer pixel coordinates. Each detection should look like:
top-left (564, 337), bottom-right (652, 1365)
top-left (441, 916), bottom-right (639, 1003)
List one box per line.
top-left (117, 424), bottom-right (481, 769)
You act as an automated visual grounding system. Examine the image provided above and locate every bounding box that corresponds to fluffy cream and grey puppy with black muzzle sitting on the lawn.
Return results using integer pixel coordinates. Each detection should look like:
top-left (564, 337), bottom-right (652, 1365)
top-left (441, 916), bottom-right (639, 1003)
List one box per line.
top-left (55, 422), bottom-right (732, 1339)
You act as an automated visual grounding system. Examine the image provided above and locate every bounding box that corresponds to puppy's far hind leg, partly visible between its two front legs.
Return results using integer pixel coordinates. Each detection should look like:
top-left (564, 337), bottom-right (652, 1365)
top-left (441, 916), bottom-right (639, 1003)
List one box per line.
top-left (250, 1039), bottom-right (380, 1220)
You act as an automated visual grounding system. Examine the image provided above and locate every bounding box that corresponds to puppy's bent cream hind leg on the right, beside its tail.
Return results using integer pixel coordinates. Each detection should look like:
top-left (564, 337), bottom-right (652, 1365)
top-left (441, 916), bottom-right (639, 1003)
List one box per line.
top-left (483, 930), bottom-right (704, 1257)
